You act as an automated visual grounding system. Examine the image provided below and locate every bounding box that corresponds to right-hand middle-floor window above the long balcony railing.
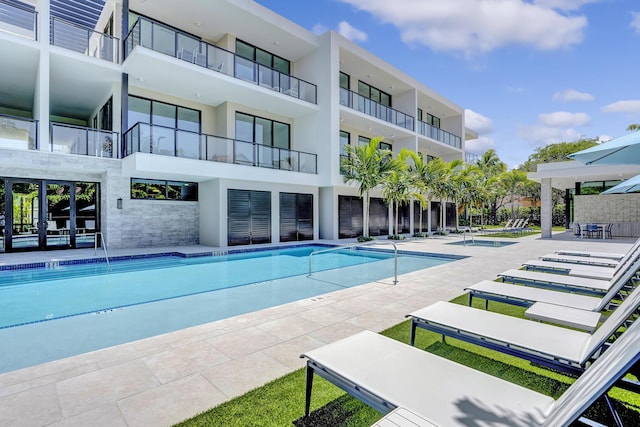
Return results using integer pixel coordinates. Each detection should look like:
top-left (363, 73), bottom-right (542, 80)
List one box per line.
top-left (236, 112), bottom-right (290, 149)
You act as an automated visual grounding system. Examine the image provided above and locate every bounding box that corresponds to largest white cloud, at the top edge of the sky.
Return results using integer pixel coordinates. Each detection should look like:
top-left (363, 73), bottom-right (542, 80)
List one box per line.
top-left (340, 0), bottom-right (587, 57)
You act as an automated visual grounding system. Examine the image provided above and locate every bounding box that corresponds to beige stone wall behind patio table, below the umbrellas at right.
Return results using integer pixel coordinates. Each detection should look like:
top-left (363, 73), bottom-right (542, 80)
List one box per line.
top-left (573, 193), bottom-right (640, 237)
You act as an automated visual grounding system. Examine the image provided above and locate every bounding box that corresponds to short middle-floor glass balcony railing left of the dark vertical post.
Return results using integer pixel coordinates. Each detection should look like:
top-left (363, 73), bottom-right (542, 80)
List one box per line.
top-left (51, 123), bottom-right (119, 159)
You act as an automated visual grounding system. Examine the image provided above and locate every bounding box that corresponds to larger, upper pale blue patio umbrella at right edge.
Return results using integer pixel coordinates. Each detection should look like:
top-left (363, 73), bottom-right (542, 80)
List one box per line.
top-left (568, 132), bottom-right (640, 165)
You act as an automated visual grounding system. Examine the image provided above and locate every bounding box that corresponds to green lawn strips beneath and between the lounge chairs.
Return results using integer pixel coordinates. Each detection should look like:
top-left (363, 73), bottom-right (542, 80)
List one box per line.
top-left (178, 295), bottom-right (640, 427)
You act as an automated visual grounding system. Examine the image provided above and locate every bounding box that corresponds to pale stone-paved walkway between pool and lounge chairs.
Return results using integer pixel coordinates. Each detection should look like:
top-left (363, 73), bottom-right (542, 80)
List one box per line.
top-left (0, 235), bottom-right (632, 427)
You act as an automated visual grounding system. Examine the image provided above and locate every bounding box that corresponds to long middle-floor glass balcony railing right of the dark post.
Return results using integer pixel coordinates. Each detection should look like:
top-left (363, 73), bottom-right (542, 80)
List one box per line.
top-left (123, 123), bottom-right (317, 174)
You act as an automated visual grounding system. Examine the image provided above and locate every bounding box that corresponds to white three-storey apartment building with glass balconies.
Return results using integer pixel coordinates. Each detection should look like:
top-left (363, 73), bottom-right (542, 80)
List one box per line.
top-left (0, 0), bottom-right (477, 252)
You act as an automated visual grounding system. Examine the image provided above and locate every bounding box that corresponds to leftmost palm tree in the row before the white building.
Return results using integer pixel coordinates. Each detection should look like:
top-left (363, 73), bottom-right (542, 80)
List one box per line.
top-left (341, 138), bottom-right (392, 238)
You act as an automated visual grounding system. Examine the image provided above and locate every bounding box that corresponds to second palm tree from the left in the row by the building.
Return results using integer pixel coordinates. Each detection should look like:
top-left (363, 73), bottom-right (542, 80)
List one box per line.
top-left (382, 148), bottom-right (421, 237)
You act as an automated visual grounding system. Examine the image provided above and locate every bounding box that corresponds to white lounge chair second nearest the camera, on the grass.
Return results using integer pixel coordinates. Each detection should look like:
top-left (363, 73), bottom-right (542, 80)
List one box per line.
top-left (406, 280), bottom-right (640, 375)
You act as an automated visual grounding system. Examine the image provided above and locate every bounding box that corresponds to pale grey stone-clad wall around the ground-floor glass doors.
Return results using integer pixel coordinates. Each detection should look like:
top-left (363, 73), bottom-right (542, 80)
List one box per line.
top-left (0, 149), bottom-right (200, 249)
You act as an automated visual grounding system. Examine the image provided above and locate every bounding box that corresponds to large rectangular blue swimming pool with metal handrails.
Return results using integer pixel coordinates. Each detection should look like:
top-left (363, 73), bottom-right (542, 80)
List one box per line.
top-left (0, 245), bottom-right (457, 372)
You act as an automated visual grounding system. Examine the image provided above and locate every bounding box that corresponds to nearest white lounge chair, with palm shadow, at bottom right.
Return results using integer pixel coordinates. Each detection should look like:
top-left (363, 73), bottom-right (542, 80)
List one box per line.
top-left (301, 322), bottom-right (640, 427)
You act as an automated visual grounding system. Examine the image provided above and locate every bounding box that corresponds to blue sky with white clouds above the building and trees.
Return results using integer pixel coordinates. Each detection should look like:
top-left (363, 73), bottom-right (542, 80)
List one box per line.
top-left (257, 0), bottom-right (640, 168)
